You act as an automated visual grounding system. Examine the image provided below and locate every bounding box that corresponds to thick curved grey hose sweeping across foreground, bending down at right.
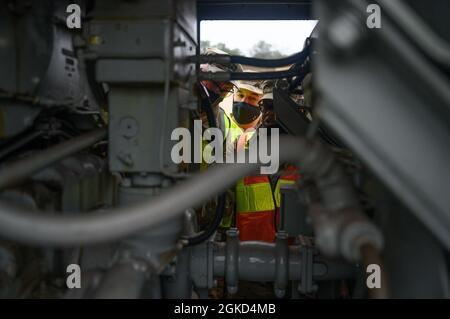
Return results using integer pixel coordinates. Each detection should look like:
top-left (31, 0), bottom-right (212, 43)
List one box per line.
top-left (0, 137), bottom-right (376, 246)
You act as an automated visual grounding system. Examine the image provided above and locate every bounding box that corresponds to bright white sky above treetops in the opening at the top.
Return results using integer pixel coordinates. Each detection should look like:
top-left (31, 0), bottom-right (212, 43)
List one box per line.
top-left (200, 20), bottom-right (317, 56)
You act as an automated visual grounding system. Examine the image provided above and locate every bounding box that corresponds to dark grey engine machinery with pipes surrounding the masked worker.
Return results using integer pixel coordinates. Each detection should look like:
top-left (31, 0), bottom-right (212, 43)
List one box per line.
top-left (0, 0), bottom-right (450, 299)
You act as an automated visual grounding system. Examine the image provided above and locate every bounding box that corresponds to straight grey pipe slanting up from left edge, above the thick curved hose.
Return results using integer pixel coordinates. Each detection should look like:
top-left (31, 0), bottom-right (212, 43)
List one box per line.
top-left (0, 128), bottom-right (106, 190)
